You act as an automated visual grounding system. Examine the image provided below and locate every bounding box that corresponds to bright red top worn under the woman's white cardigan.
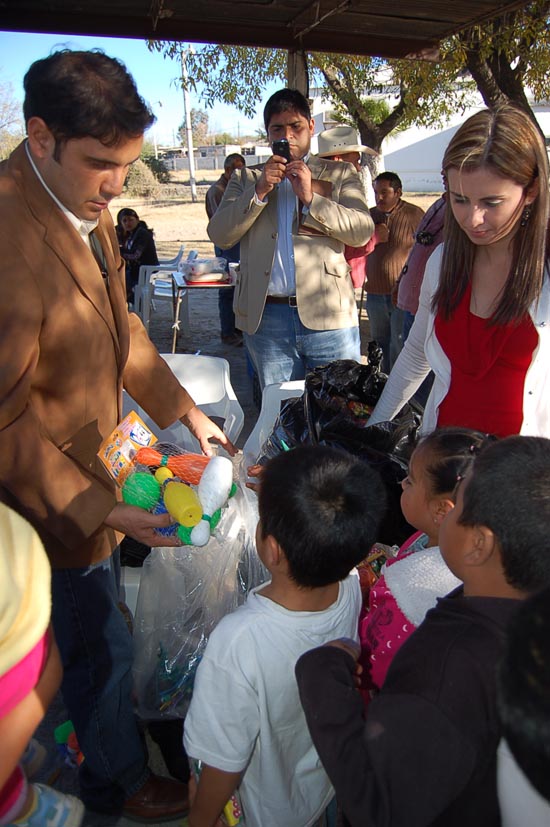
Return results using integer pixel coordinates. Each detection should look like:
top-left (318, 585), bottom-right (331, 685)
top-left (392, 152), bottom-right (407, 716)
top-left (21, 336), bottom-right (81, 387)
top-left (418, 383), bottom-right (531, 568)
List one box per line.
top-left (435, 285), bottom-right (538, 437)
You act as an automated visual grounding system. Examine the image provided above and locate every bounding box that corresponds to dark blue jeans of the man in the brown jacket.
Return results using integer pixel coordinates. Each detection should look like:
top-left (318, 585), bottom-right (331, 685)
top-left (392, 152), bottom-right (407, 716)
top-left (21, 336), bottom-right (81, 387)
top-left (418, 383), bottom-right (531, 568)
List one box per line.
top-left (52, 552), bottom-right (149, 810)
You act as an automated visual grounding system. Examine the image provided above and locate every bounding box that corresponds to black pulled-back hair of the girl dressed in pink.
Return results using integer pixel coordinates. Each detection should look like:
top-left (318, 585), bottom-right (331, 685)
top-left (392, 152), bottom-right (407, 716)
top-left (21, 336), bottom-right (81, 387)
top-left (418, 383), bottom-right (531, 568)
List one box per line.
top-left (416, 428), bottom-right (492, 497)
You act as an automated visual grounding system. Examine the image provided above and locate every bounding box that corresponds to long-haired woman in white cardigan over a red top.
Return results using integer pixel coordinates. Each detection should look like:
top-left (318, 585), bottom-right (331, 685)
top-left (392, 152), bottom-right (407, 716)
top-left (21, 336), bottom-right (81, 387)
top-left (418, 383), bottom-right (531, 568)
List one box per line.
top-left (370, 105), bottom-right (550, 437)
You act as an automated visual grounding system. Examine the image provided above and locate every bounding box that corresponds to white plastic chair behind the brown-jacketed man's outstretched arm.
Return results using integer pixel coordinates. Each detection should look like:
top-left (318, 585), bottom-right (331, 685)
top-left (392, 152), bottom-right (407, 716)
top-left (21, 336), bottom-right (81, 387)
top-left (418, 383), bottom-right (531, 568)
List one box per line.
top-left (121, 353), bottom-right (244, 614)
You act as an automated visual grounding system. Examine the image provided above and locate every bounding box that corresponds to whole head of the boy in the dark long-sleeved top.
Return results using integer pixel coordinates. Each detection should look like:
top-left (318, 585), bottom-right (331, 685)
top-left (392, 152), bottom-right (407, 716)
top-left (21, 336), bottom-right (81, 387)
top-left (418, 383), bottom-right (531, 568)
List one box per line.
top-left (439, 436), bottom-right (550, 596)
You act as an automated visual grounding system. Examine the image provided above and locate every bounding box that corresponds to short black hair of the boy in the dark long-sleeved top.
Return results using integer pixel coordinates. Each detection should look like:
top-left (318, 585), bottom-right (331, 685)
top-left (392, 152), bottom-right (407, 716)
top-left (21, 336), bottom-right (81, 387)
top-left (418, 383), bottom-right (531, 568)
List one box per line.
top-left (459, 436), bottom-right (550, 592)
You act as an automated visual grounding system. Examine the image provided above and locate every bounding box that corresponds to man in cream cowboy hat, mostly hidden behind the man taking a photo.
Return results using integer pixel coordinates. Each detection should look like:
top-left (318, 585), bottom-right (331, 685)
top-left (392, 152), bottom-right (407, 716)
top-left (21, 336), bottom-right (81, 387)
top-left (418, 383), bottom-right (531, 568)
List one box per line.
top-left (317, 126), bottom-right (388, 288)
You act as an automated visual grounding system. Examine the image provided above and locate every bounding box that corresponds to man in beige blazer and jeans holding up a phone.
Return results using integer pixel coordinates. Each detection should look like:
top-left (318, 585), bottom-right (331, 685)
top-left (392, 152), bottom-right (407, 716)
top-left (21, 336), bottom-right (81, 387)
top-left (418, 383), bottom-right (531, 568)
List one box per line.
top-left (208, 89), bottom-right (374, 389)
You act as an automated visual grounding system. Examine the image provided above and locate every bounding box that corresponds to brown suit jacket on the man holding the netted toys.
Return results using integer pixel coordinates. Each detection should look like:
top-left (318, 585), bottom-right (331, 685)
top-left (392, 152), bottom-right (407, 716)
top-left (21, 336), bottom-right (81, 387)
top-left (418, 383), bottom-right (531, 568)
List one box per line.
top-left (0, 144), bottom-right (193, 568)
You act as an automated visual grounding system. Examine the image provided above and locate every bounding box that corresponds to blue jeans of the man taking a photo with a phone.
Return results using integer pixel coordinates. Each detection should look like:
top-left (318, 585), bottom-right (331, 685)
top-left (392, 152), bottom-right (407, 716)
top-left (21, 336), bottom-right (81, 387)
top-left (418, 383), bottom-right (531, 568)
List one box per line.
top-left (244, 304), bottom-right (361, 390)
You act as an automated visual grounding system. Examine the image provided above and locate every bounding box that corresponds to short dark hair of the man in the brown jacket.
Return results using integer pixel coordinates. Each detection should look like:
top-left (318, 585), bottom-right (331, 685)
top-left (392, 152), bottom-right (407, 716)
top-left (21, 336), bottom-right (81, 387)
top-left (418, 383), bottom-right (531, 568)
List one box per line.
top-left (23, 49), bottom-right (155, 146)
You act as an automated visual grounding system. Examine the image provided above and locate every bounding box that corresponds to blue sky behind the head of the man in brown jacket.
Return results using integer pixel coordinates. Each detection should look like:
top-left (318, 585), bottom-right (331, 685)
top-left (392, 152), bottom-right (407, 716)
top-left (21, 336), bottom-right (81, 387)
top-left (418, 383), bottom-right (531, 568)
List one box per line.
top-left (0, 32), bottom-right (268, 145)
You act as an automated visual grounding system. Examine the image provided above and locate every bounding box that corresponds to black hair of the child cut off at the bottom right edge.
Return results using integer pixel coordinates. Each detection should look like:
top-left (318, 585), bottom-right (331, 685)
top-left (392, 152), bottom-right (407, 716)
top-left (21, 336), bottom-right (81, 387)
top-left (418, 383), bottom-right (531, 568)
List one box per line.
top-left (497, 589), bottom-right (550, 804)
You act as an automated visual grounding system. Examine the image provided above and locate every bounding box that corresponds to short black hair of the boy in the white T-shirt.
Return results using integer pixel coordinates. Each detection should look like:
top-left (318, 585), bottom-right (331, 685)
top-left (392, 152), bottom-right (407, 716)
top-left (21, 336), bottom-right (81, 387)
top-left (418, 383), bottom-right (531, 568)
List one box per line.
top-left (258, 446), bottom-right (386, 588)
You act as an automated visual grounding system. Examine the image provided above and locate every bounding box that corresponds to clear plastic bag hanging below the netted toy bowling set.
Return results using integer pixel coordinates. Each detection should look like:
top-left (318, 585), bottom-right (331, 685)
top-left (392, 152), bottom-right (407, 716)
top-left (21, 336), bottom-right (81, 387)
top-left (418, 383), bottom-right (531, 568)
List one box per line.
top-left (134, 488), bottom-right (267, 719)
